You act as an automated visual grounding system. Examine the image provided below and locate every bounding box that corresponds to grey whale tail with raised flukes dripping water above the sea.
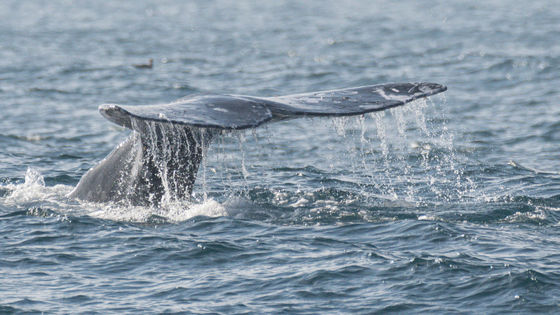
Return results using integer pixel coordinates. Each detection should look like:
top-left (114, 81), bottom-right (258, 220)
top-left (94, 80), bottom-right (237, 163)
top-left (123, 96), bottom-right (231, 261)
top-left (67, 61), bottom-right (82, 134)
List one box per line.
top-left (69, 82), bottom-right (447, 206)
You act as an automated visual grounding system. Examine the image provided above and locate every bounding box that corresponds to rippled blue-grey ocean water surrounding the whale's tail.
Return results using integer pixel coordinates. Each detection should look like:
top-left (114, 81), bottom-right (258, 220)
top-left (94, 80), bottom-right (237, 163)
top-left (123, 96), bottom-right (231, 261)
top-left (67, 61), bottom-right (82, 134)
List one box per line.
top-left (0, 0), bottom-right (560, 314)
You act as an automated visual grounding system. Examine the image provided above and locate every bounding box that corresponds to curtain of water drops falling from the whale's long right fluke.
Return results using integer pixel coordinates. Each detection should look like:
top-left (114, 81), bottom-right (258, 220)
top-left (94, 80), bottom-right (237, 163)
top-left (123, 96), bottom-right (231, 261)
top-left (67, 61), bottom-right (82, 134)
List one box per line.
top-left (187, 96), bottom-right (473, 217)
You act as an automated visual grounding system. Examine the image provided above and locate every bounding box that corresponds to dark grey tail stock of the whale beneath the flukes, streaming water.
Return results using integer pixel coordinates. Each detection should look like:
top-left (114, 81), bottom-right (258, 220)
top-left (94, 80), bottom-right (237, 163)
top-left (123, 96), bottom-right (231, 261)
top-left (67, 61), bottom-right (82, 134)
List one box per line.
top-left (69, 125), bottom-right (212, 206)
